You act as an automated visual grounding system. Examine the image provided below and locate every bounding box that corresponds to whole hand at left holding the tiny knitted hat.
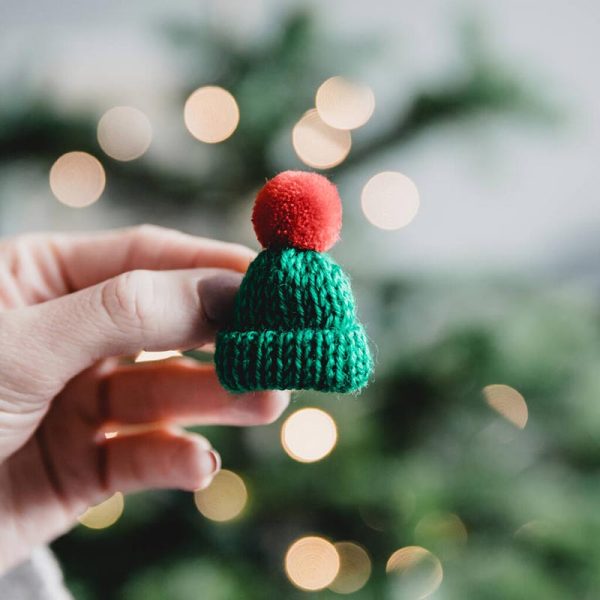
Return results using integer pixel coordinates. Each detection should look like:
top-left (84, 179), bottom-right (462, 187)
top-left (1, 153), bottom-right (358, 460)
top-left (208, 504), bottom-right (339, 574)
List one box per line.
top-left (0, 226), bottom-right (288, 572)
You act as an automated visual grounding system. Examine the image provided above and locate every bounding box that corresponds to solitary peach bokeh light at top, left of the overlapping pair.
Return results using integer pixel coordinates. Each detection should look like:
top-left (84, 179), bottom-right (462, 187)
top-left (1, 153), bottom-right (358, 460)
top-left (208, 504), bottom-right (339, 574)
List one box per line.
top-left (183, 85), bottom-right (240, 144)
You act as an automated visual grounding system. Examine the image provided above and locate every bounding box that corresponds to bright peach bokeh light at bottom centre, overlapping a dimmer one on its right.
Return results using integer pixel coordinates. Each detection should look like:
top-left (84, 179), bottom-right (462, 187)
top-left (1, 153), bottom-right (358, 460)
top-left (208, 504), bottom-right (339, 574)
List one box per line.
top-left (285, 536), bottom-right (340, 591)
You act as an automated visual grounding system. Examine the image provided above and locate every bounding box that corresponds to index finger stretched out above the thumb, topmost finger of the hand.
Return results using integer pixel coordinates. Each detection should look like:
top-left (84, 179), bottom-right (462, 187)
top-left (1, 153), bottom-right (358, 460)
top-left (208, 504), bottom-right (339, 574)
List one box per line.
top-left (46, 225), bottom-right (256, 291)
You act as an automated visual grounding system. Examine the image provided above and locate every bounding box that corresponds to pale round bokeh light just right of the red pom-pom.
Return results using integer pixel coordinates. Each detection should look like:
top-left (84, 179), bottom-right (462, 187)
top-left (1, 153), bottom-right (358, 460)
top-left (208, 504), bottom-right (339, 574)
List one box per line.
top-left (361, 171), bottom-right (420, 230)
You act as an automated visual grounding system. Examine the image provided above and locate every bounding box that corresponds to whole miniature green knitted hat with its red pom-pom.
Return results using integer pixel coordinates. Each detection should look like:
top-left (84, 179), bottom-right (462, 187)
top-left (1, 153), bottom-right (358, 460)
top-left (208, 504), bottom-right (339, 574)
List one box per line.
top-left (215, 171), bottom-right (373, 393)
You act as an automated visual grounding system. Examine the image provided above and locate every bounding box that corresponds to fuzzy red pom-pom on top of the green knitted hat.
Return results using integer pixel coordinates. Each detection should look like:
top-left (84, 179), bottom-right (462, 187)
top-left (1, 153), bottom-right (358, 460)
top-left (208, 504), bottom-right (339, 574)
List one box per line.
top-left (252, 171), bottom-right (342, 252)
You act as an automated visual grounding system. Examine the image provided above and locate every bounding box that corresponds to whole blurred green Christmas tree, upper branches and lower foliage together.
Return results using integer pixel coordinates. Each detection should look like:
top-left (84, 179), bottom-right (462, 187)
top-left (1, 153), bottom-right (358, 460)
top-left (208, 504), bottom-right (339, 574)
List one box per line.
top-left (0, 8), bottom-right (600, 600)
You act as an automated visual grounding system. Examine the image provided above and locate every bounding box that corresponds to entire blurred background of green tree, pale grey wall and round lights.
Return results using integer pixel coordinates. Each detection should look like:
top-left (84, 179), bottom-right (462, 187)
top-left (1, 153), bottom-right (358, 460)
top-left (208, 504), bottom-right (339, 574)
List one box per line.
top-left (0, 0), bottom-right (600, 600)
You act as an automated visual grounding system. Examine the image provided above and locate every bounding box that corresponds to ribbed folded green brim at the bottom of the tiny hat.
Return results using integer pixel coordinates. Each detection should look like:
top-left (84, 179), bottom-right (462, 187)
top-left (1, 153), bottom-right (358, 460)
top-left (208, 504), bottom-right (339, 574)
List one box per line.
top-left (215, 324), bottom-right (373, 393)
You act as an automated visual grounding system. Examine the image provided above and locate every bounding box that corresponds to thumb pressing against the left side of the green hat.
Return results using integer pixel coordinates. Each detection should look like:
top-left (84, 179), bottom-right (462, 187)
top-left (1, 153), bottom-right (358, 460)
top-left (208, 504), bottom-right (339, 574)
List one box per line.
top-left (11, 269), bottom-right (242, 383)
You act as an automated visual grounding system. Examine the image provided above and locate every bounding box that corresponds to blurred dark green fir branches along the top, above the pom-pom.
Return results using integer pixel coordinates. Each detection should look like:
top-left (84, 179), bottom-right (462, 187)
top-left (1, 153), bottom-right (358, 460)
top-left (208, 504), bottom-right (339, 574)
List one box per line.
top-left (0, 13), bottom-right (545, 219)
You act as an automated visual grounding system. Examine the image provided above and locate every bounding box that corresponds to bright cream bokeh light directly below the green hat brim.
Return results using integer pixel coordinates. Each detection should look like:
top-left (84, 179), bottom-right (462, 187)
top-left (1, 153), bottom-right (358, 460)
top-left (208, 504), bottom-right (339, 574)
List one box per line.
top-left (281, 408), bottom-right (337, 463)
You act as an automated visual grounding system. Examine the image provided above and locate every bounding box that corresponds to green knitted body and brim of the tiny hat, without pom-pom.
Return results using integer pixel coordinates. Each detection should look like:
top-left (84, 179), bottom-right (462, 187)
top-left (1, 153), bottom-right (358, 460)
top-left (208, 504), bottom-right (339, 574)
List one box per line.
top-left (215, 248), bottom-right (373, 393)
